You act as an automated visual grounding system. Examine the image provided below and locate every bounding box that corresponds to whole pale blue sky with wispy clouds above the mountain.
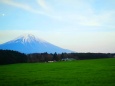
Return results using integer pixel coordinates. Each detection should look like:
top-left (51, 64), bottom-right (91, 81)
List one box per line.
top-left (0, 0), bottom-right (115, 53)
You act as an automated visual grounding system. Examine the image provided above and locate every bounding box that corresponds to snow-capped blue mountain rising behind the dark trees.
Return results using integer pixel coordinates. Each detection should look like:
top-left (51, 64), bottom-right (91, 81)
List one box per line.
top-left (0, 34), bottom-right (72, 54)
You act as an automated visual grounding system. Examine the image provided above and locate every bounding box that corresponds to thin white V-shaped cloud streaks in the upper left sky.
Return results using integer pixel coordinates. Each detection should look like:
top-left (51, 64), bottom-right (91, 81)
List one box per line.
top-left (0, 0), bottom-right (56, 19)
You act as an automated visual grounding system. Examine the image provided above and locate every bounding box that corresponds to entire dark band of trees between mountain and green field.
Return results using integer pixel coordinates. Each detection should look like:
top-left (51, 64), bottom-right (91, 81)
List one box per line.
top-left (0, 50), bottom-right (115, 65)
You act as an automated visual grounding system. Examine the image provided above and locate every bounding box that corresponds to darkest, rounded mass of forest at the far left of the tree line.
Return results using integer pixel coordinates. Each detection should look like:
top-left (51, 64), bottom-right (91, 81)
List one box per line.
top-left (0, 50), bottom-right (27, 65)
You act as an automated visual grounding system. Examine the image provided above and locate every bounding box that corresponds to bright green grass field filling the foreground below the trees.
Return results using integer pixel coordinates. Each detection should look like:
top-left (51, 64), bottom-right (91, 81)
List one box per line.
top-left (0, 58), bottom-right (115, 86)
